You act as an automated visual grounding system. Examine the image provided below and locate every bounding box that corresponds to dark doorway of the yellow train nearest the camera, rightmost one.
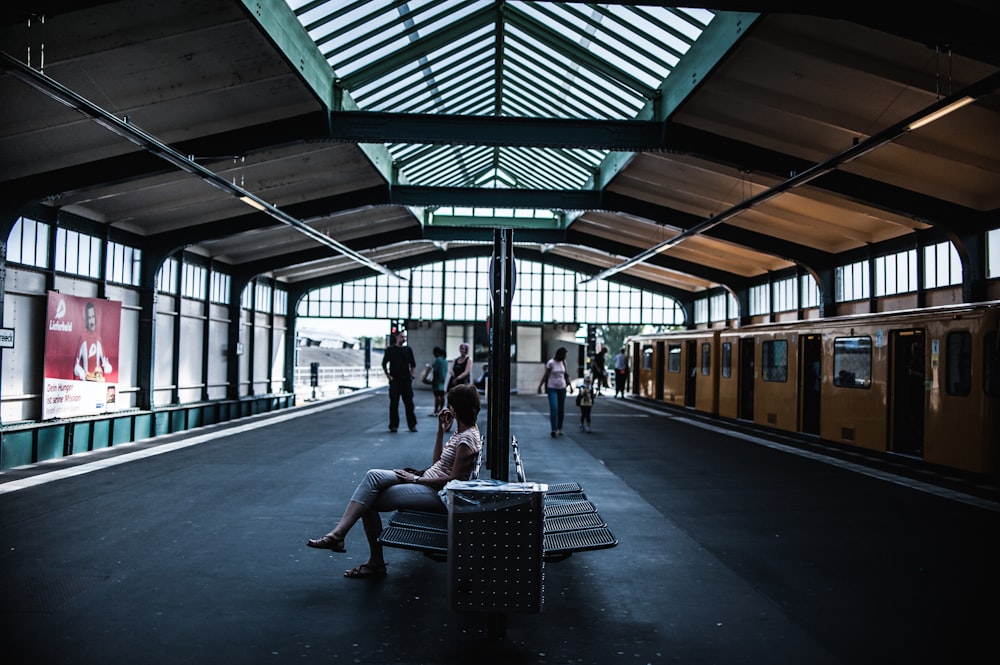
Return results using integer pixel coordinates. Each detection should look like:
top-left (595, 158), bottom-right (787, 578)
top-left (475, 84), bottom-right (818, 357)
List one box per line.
top-left (889, 330), bottom-right (927, 457)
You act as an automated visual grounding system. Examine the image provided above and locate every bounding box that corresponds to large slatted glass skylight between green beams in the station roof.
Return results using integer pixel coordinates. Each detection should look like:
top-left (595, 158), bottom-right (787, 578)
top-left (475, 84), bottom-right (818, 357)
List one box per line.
top-left (288, 0), bottom-right (713, 189)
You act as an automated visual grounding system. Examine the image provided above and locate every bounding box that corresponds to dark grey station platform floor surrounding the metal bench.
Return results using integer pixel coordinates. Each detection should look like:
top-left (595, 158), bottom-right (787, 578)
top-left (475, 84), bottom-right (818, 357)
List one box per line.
top-left (0, 389), bottom-right (1000, 665)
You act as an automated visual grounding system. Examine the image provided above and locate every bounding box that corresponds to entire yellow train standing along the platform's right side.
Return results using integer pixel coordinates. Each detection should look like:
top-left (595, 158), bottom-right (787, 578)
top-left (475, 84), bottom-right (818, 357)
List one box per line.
top-left (627, 301), bottom-right (1000, 476)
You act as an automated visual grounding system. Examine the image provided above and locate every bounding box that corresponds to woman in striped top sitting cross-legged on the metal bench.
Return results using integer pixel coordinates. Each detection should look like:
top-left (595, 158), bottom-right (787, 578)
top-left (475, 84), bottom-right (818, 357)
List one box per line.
top-left (306, 383), bottom-right (482, 579)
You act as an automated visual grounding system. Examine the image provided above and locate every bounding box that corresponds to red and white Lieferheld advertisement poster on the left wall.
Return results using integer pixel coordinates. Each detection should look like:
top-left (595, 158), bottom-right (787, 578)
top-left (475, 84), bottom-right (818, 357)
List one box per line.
top-left (42, 291), bottom-right (122, 420)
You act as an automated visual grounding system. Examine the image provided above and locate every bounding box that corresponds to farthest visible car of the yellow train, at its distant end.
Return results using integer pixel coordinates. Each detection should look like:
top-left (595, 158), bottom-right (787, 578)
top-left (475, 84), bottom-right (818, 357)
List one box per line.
top-left (628, 330), bottom-right (719, 416)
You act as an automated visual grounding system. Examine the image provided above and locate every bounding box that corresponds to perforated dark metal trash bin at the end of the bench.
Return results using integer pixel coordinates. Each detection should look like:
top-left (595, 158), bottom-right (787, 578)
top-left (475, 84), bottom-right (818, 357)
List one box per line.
top-left (447, 480), bottom-right (547, 613)
